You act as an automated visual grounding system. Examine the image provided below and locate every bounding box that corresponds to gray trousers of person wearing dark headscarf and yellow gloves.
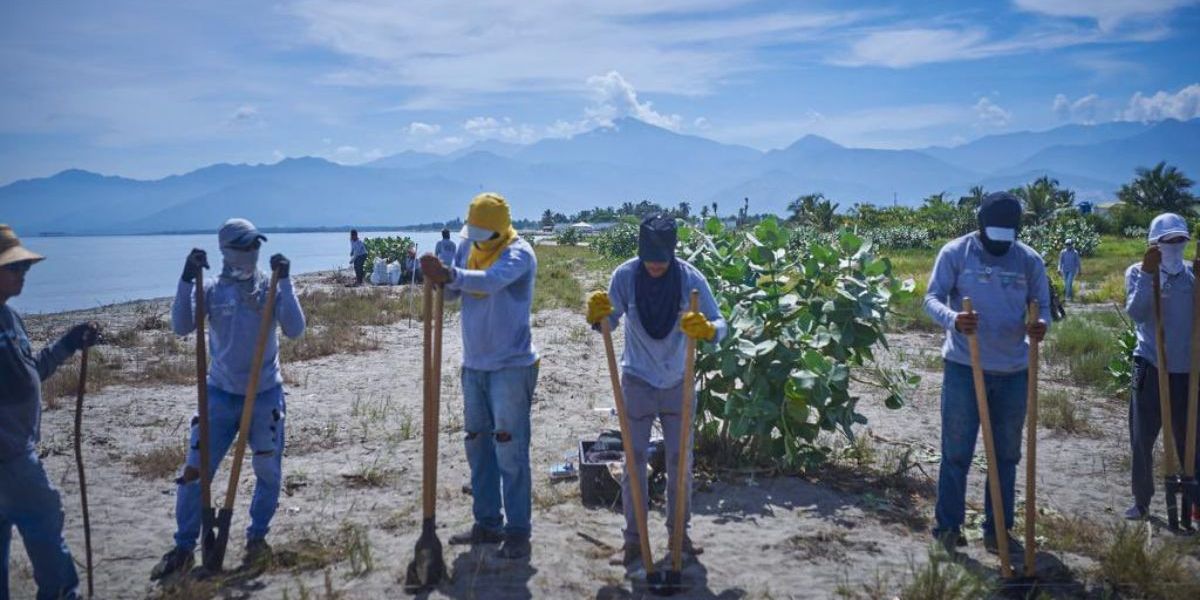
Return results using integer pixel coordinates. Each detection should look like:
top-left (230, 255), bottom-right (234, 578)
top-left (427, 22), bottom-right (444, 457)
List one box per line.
top-left (620, 373), bottom-right (696, 545)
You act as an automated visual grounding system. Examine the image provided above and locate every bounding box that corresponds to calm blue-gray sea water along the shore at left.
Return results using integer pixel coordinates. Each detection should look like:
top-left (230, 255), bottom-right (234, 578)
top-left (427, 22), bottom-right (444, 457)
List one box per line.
top-left (8, 232), bottom-right (448, 314)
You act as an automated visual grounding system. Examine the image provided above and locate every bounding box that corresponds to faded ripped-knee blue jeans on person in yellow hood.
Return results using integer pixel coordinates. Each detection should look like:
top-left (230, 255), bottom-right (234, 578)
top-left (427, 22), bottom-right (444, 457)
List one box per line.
top-left (462, 365), bottom-right (538, 536)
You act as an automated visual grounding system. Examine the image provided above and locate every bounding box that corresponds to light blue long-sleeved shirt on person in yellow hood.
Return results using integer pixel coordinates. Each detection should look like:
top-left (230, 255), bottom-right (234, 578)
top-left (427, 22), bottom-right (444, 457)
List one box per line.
top-left (445, 238), bottom-right (538, 371)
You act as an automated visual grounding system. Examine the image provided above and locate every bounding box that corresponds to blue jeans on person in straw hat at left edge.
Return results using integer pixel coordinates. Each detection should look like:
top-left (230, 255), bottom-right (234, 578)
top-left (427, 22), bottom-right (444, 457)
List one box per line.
top-left (0, 451), bottom-right (79, 600)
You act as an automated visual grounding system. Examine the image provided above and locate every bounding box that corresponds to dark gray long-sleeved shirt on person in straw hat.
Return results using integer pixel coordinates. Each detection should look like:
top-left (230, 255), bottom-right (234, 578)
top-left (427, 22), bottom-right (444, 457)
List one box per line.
top-left (0, 305), bottom-right (72, 462)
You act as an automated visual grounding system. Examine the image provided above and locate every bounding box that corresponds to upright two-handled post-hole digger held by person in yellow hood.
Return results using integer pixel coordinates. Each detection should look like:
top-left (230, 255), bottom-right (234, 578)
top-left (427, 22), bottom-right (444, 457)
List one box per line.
top-left (404, 278), bottom-right (446, 594)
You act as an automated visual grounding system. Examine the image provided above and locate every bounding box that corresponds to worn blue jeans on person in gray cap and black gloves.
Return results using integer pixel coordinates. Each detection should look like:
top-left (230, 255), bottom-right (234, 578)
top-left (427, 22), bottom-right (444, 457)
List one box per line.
top-left (175, 385), bottom-right (287, 551)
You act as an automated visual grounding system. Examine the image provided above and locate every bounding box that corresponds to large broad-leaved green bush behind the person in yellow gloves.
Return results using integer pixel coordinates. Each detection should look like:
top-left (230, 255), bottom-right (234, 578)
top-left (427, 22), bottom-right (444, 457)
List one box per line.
top-left (679, 217), bottom-right (916, 468)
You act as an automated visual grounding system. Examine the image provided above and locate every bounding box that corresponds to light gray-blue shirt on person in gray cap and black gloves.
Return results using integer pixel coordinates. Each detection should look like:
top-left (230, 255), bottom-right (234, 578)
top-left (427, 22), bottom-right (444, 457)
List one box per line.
top-left (170, 276), bottom-right (305, 396)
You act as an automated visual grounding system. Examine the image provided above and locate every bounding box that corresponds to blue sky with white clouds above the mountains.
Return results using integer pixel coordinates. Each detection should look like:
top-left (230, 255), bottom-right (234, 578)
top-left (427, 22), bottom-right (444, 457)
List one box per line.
top-left (0, 0), bottom-right (1200, 185)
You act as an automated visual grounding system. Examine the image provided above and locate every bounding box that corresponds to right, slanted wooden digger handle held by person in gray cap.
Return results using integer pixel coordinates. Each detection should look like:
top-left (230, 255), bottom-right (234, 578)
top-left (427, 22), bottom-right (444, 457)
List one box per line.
top-left (207, 269), bottom-right (280, 574)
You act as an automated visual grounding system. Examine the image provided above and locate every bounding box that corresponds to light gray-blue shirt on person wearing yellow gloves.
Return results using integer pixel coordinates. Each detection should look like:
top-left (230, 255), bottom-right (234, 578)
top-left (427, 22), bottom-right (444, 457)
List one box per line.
top-left (608, 258), bottom-right (728, 390)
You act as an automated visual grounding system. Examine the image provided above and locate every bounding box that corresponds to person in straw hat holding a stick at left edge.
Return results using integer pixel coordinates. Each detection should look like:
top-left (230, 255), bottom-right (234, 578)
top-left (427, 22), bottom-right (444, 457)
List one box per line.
top-left (0, 224), bottom-right (100, 600)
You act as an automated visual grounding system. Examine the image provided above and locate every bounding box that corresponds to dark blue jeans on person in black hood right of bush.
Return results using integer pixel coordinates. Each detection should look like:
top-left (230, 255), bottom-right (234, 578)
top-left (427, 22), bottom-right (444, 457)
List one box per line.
top-left (934, 360), bottom-right (1028, 534)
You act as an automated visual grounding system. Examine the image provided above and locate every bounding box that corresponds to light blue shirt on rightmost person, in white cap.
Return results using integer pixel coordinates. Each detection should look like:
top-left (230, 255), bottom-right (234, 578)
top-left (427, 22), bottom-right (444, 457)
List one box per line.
top-left (1126, 262), bottom-right (1195, 373)
